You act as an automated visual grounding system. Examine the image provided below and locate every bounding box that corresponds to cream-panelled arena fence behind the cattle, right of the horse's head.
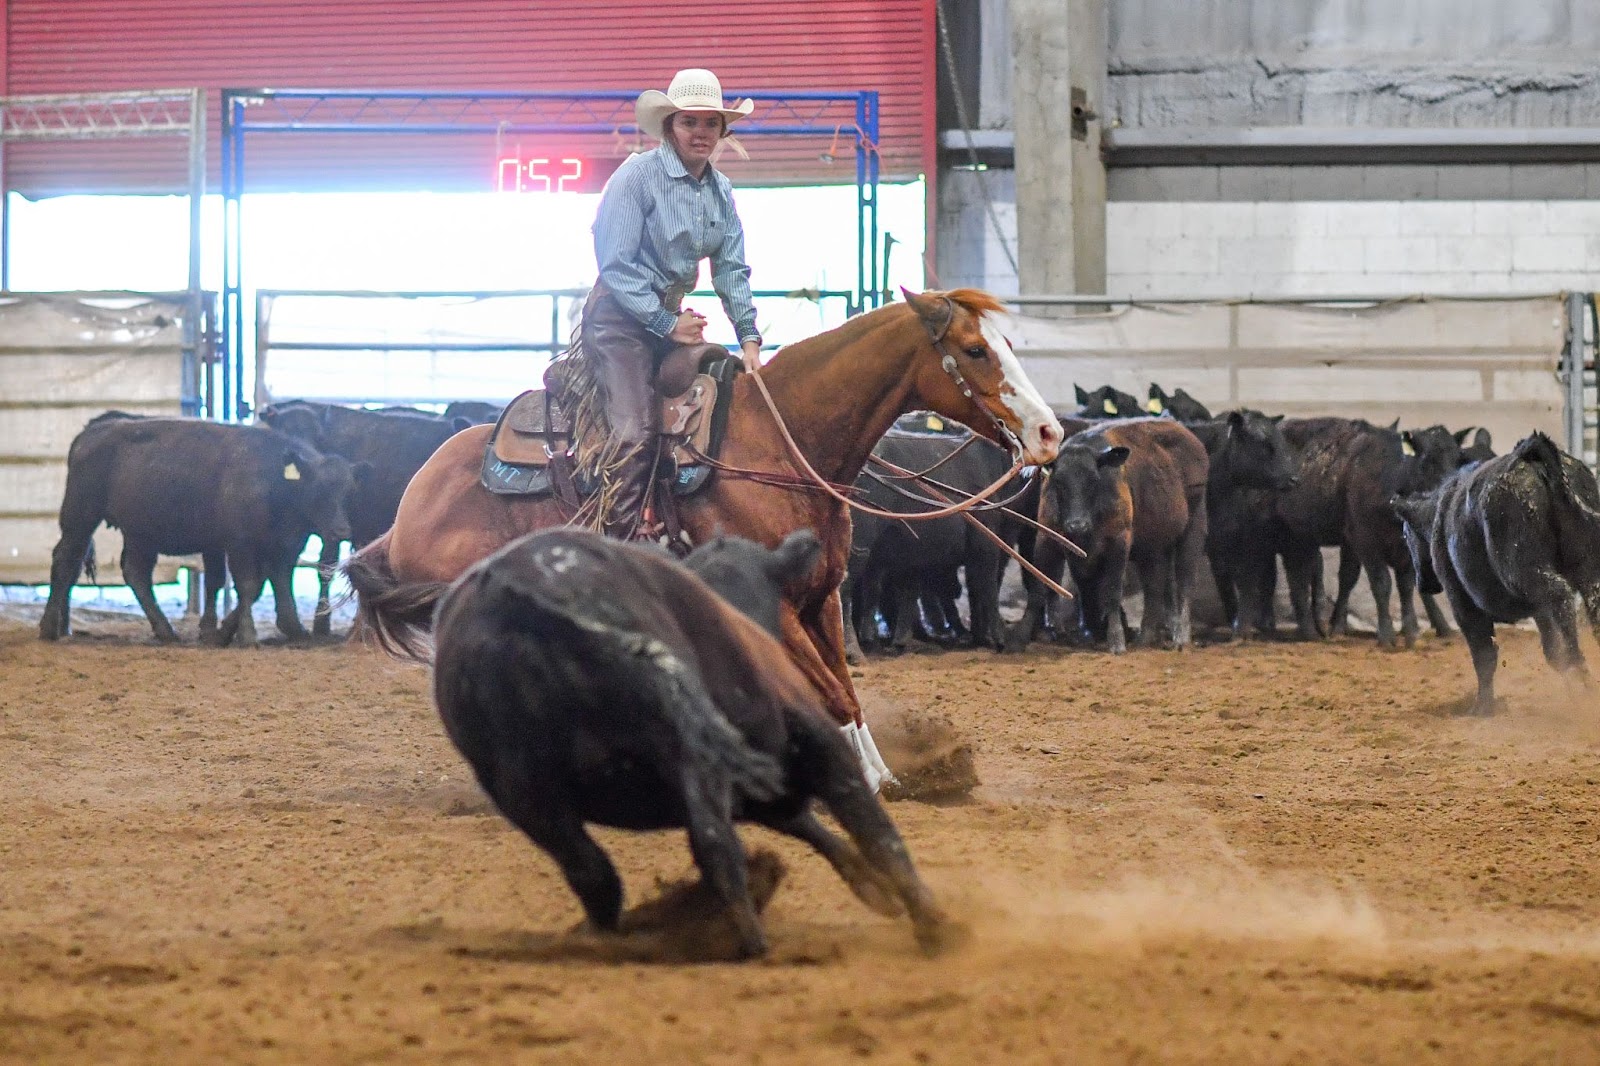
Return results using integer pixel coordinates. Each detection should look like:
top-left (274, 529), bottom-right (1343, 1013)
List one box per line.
top-left (1011, 295), bottom-right (1595, 464)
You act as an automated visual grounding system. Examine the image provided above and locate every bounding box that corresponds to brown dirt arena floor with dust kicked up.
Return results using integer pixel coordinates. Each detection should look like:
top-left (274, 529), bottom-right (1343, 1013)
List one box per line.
top-left (0, 610), bottom-right (1600, 1064)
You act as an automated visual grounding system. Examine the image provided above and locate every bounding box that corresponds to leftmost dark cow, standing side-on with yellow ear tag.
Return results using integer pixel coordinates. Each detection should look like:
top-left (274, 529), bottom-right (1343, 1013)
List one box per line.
top-left (38, 416), bottom-right (360, 645)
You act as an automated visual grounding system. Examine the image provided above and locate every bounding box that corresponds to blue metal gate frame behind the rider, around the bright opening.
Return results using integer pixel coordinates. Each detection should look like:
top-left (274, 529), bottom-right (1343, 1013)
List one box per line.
top-left (213, 88), bottom-right (883, 419)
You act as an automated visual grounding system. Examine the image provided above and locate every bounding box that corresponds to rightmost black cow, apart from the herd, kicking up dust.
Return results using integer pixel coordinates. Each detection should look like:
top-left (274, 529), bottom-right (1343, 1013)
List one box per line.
top-left (1392, 432), bottom-right (1600, 715)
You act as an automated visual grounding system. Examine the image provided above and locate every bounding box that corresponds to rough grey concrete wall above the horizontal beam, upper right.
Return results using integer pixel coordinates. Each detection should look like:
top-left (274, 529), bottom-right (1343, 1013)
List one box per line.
top-left (1107, 0), bottom-right (1600, 126)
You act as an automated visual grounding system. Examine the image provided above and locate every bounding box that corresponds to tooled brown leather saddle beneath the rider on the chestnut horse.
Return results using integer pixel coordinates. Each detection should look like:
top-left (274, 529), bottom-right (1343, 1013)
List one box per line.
top-left (480, 344), bottom-right (744, 503)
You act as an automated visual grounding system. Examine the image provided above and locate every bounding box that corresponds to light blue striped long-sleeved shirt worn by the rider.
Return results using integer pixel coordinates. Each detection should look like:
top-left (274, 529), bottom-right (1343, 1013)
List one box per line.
top-left (594, 144), bottom-right (762, 343)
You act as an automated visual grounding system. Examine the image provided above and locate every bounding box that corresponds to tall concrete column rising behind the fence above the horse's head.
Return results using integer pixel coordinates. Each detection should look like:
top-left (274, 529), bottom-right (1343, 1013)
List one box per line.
top-left (1010, 0), bottom-right (1106, 295)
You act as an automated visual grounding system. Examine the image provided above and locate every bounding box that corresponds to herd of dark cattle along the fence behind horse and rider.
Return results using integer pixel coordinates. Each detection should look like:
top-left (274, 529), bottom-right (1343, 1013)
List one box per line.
top-left (31, 377), bottom-right (1600, 709)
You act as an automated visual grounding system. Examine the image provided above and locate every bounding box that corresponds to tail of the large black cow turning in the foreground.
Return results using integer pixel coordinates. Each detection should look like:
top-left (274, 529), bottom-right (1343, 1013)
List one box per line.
top-left (480, 571), bottom-right (784, 802)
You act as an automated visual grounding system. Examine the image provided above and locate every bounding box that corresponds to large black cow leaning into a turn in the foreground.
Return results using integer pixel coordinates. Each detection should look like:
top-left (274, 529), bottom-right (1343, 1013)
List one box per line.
top-left (434, 528), bottom-right (947, 957)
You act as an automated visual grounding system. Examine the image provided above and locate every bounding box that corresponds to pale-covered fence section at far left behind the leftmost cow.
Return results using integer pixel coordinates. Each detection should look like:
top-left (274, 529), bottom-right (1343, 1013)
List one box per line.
top-left (0, 293), bottom-right (202, 584)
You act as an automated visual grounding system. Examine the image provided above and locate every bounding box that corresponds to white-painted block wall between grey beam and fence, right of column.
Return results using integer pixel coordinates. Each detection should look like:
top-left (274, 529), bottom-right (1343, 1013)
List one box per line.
top-left (1100, 200), bottom-right (1600, 296)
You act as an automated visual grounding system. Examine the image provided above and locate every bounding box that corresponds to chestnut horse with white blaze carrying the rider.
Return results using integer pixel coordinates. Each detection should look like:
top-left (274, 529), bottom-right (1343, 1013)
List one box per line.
top-left (346, 288), bottom-right (1062, 784)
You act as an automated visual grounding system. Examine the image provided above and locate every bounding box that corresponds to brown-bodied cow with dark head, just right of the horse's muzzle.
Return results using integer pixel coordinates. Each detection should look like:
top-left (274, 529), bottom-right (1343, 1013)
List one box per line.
top-left (1006, 418), bottom-right (1210, 655)
